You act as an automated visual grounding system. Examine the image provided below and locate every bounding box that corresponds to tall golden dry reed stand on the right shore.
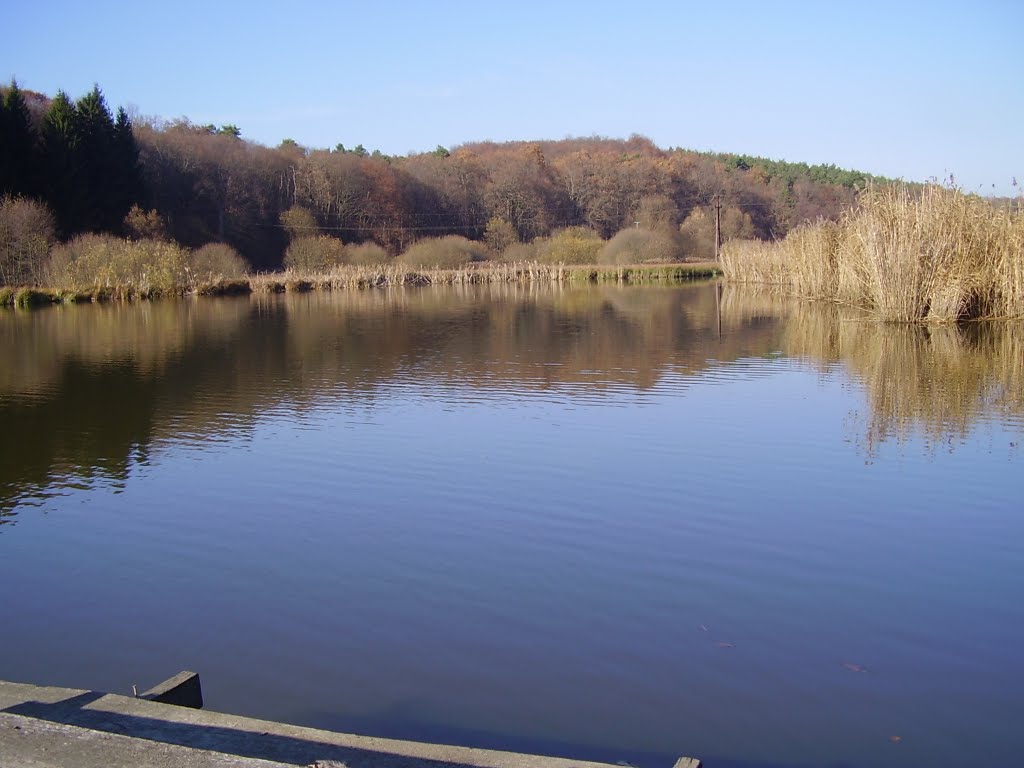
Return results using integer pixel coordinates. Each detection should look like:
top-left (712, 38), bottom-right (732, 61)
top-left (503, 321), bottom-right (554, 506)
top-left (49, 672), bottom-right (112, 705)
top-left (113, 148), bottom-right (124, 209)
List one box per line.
top-left (722, 184), bottom-right (1024, 323)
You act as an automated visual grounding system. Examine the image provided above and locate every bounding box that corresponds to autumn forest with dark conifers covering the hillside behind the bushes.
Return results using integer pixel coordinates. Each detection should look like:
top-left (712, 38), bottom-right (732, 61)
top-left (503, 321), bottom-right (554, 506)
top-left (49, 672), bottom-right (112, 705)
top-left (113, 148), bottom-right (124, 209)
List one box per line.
top-left (0, 83), bottom-right (888, 282)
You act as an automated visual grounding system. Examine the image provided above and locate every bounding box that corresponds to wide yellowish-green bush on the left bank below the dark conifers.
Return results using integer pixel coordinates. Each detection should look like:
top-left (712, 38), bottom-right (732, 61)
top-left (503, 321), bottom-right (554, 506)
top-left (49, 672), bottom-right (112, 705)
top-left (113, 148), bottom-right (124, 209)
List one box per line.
top-left (45, 234), bottom-right (189, 297)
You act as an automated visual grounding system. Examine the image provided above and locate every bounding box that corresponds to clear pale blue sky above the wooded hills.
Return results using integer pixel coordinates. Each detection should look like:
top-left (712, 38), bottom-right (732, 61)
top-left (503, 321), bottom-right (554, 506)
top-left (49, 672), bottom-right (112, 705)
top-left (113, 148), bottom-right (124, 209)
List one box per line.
top-left (0, 0), bottom-right (1024, 195)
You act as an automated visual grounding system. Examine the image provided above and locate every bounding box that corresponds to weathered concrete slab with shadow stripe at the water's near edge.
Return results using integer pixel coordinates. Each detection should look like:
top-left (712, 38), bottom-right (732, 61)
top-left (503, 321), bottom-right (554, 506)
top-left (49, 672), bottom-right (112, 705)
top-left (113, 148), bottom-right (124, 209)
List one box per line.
top-left (0, 681), bottom-right (699, 768)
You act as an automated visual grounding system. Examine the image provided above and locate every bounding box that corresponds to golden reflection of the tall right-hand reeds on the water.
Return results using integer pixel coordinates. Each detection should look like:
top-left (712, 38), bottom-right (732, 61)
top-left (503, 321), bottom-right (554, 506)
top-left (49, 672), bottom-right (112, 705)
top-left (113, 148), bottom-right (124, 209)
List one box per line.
top-left (722, 288), bottom-right (1024, 454)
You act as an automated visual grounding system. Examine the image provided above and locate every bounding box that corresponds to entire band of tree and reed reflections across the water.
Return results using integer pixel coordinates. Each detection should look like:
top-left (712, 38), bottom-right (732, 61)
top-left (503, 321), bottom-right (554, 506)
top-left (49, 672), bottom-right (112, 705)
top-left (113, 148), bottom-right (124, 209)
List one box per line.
top-left (0, 286), bottom-right (1024, 510)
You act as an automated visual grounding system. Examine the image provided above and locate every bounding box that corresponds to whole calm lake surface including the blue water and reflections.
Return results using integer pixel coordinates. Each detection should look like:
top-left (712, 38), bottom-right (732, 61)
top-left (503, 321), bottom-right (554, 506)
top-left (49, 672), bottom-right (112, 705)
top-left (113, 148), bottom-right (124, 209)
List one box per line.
top-left (0, 285), bottom-right (1024, 768)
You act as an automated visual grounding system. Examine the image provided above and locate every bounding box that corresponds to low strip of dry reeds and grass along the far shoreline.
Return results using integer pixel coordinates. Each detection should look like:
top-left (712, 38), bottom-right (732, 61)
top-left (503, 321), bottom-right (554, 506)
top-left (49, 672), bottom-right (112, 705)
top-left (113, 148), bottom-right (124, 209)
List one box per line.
top-left (0, 262), bottom-right (722, 307)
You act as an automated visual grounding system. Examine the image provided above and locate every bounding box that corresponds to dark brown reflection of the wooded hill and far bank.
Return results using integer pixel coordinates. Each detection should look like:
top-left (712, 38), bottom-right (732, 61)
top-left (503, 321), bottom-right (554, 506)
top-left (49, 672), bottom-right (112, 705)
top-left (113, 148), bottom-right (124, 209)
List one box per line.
top-left (0, 286), bottom-right (771, 508)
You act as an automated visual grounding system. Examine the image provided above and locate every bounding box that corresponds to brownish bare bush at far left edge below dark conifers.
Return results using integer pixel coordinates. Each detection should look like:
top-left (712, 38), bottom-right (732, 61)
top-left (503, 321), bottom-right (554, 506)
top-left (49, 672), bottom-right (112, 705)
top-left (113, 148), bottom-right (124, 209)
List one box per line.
top-left (0, 197), bottom-right (53, 286)
